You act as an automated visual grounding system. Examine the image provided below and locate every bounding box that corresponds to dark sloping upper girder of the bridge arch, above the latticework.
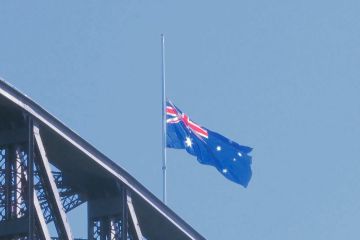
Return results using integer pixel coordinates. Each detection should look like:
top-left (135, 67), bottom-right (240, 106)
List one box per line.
top-left (0, 79), bottom-right (204, 240)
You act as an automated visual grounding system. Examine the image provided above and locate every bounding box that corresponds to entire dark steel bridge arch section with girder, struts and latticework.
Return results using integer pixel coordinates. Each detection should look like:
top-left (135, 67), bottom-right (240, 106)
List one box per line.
top-left (0, 80), bottom-right (205, 240)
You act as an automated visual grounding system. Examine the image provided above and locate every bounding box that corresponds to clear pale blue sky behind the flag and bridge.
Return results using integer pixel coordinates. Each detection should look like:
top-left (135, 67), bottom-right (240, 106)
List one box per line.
top-left (0, 0), bottom-right (360, 240)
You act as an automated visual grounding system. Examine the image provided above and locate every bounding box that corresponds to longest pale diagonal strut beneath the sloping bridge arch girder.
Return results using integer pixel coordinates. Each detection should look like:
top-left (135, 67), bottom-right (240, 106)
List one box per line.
top-left (34, 125), bottom-right (73, 240)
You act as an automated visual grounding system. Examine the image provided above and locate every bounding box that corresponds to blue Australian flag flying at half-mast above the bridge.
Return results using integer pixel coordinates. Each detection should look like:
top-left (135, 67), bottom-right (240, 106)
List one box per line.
top-left (166, 101), bottom-right (252, 187)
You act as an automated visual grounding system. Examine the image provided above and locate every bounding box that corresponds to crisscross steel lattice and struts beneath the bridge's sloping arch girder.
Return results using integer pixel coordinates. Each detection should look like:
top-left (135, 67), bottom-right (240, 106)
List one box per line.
top-left (0, 121), bottom-right (146, 240)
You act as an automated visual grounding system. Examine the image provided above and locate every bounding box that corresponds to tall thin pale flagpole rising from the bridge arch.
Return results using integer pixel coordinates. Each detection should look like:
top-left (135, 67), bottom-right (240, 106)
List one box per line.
top-left (161, 34), bottom-right (166, 204)
